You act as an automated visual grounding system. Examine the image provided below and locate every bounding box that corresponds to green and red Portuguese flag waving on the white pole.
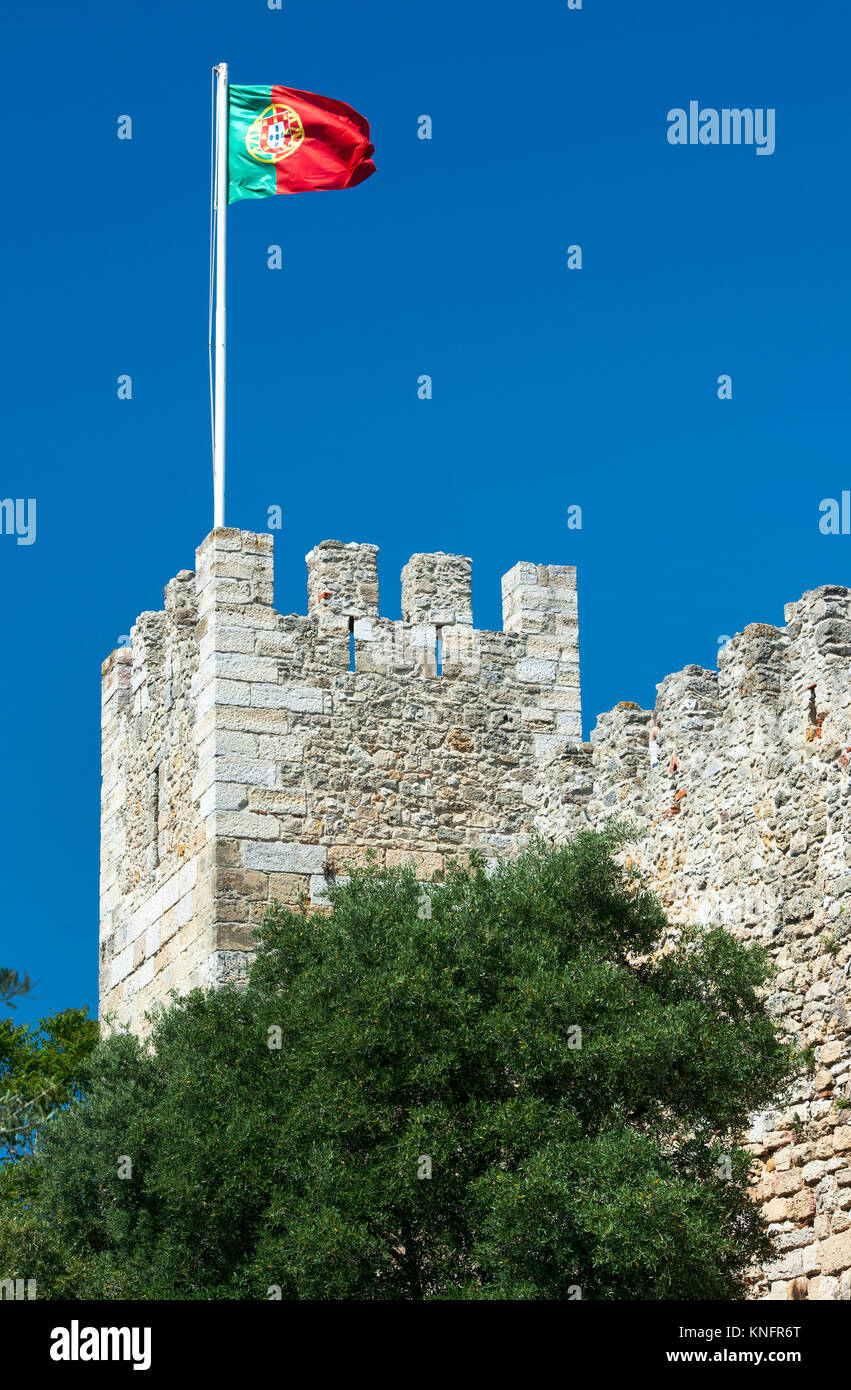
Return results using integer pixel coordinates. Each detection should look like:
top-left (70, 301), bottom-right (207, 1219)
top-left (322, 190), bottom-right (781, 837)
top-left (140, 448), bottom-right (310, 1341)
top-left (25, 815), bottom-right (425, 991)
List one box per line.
top-left (228, 86), bottom-right (375, 203)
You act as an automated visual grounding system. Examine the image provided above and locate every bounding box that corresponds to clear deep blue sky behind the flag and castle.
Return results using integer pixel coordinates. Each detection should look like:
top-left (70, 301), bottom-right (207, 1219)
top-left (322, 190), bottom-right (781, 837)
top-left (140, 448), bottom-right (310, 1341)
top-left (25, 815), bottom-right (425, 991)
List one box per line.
top-left (0, 0), bottom-right (851, 1019)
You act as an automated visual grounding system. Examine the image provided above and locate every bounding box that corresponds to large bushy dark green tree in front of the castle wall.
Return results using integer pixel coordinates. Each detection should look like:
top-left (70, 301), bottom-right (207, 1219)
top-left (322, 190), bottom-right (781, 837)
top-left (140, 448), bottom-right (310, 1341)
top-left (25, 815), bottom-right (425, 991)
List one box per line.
top-left (0, 830), bottom-right (804, 1300)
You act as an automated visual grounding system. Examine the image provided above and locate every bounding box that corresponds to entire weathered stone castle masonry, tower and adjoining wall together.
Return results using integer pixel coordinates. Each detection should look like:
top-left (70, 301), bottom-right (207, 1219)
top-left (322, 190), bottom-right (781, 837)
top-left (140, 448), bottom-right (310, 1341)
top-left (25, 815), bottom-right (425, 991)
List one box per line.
top-left (100, 530), bottom-right (851, 1300)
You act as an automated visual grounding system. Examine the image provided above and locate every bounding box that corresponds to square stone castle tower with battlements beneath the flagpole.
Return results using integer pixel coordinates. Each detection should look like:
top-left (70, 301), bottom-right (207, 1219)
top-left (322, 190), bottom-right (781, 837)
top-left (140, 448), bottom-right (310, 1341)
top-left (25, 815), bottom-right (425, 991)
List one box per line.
top-left (100, 528), bottom-right (581, 1033)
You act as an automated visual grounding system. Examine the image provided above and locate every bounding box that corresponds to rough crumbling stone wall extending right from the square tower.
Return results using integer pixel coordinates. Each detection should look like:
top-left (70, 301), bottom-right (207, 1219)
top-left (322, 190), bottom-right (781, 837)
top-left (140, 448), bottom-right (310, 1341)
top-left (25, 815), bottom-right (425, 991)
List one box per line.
top-left (537, 587), bottom-right (851, 1300)
